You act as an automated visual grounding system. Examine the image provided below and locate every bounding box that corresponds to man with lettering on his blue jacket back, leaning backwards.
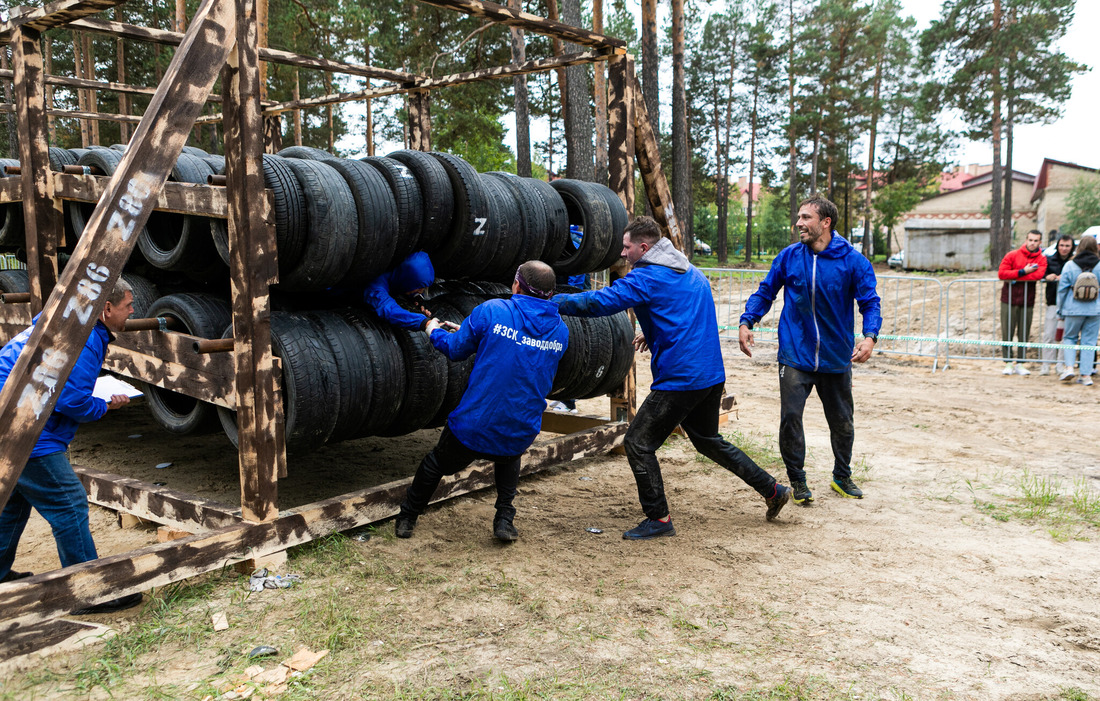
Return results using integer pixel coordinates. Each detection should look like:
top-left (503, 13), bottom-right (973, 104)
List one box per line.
top-left (394, 261), bottom-right (569, 543)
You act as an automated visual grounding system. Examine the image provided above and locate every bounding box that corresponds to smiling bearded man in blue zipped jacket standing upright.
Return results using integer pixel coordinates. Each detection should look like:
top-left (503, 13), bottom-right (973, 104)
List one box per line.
top-left (738, 197), bottom-right (882, 506)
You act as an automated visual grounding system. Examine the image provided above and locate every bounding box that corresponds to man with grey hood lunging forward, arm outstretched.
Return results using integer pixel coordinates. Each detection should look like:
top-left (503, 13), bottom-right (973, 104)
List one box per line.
top-left (554, 217), bottom-right (790, 540)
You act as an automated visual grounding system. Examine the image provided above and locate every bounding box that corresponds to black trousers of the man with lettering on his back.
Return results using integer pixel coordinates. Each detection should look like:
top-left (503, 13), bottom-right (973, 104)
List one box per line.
top-left (402, 427), bottom-right (523, 523)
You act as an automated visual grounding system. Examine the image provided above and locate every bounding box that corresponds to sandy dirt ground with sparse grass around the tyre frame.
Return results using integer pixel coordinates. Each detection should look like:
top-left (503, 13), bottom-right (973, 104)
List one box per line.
top-left (0, 346), bottom-right (1100, 700)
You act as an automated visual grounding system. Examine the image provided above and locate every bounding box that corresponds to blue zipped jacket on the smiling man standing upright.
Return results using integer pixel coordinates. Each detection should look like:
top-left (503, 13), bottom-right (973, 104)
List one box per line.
top-left (740, 231), bottom-right (882, 373)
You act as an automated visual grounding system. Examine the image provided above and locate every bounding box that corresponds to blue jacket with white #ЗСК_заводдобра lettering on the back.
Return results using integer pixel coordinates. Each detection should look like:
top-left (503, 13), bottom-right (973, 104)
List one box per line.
top-left (431, 295), bottom-right (569, 456)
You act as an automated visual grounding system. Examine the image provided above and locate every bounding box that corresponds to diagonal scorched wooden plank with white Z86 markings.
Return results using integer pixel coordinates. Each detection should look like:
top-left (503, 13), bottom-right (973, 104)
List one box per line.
top-left (0, 0), bottom-right (234, 523)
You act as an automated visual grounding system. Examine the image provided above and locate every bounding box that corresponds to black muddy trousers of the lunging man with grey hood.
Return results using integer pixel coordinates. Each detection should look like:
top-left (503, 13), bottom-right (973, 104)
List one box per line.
top-left (623, 382), bottom-right (776, 519)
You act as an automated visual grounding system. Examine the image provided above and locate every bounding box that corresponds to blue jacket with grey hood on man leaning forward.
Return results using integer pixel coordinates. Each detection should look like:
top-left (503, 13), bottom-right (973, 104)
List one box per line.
top-left (552, 239), bottom-right (726, 392)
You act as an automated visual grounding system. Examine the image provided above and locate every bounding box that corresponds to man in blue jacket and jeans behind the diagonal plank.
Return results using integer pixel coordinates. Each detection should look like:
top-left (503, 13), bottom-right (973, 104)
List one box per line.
top-left (0, 280), bottom-right (142, 615)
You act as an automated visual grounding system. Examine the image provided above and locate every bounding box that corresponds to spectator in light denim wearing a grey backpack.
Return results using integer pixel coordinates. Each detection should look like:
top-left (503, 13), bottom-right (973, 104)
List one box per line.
top-left (1058, 237), bottom-right (1100, 386)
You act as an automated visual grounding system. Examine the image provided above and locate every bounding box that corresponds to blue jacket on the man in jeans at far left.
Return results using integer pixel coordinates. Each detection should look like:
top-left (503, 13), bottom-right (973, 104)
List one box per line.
top-left (0, 317), bottom-right (111, 458)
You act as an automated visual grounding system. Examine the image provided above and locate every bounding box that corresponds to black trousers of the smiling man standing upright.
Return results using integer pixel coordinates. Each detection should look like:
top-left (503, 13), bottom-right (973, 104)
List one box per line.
top-left (779, 364), bottom-right (856, 482)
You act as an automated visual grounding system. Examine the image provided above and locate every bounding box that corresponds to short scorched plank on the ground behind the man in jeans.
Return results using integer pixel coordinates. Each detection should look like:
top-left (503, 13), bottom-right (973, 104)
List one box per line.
top-left (73, 464), bottom-right (241, 533)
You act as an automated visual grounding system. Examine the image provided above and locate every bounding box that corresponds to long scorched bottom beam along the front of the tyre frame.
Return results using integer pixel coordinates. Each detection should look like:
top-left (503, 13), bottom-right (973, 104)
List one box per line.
top-left (0, 423), bottom-right (627, 637)
